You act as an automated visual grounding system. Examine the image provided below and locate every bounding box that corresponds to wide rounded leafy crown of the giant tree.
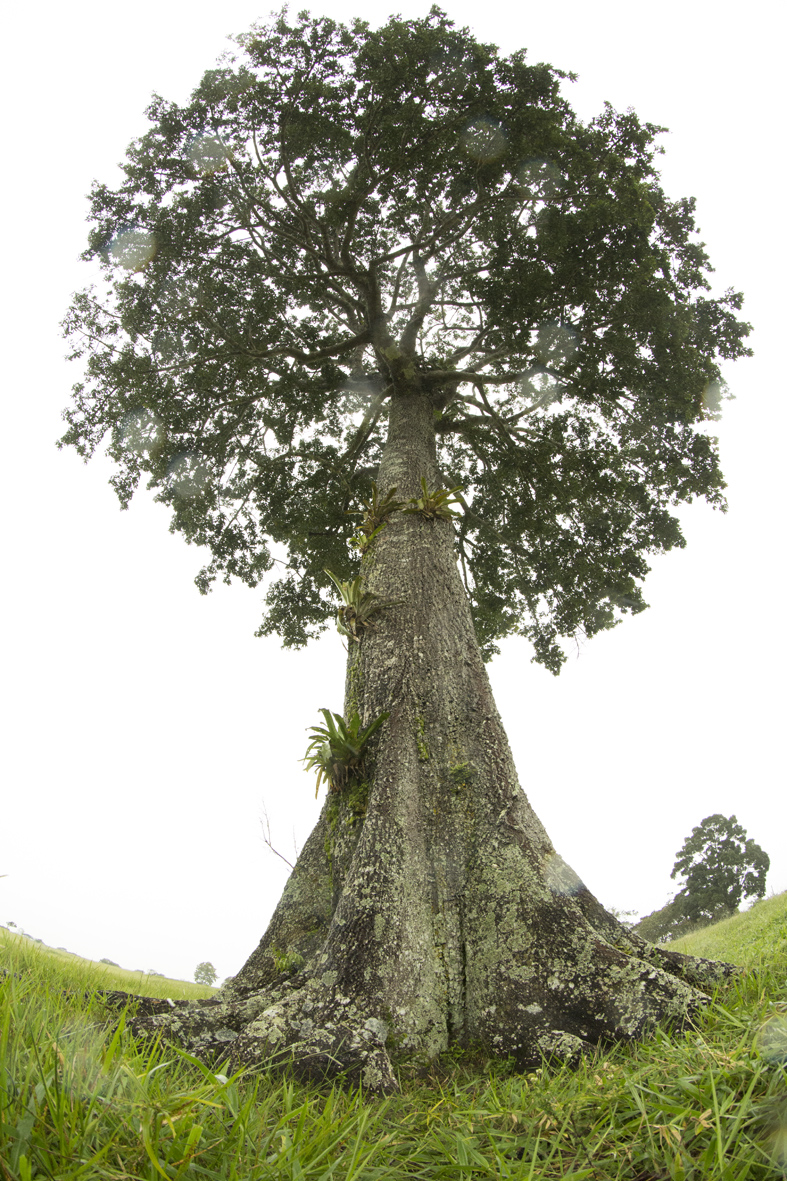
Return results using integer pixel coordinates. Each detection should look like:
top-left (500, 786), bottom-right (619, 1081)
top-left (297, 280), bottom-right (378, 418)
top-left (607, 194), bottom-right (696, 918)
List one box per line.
top-left (61, 8), bottom-right (748, 672)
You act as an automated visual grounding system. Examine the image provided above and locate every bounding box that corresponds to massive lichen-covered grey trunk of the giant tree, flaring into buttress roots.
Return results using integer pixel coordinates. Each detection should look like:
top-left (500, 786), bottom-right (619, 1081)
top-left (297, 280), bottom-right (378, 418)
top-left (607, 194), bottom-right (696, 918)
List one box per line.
top-left (127, 392), bottom-right (731, 1091)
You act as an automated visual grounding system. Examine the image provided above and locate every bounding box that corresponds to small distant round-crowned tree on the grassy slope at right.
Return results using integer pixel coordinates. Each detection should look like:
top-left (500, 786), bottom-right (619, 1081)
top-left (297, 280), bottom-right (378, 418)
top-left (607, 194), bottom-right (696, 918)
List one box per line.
top-left (670, 813), bottom-right (770, 922)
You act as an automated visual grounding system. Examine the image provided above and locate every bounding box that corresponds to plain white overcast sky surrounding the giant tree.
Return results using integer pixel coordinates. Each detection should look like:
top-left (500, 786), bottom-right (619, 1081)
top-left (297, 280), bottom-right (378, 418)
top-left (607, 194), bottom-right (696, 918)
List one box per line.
top-left (0, 0), bottom-right (787, 979)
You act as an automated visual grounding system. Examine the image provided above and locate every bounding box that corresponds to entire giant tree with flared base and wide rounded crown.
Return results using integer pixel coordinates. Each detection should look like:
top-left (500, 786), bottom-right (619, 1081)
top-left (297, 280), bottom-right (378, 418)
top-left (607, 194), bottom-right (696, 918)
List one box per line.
top-left (61, 8), bottom-right (748, 1090)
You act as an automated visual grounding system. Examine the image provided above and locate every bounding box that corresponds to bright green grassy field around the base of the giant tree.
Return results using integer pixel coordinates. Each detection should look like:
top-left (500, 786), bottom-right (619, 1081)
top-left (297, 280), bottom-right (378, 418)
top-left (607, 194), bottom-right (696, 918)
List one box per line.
top-left (0, 894), bottom-right (787, 1181)
